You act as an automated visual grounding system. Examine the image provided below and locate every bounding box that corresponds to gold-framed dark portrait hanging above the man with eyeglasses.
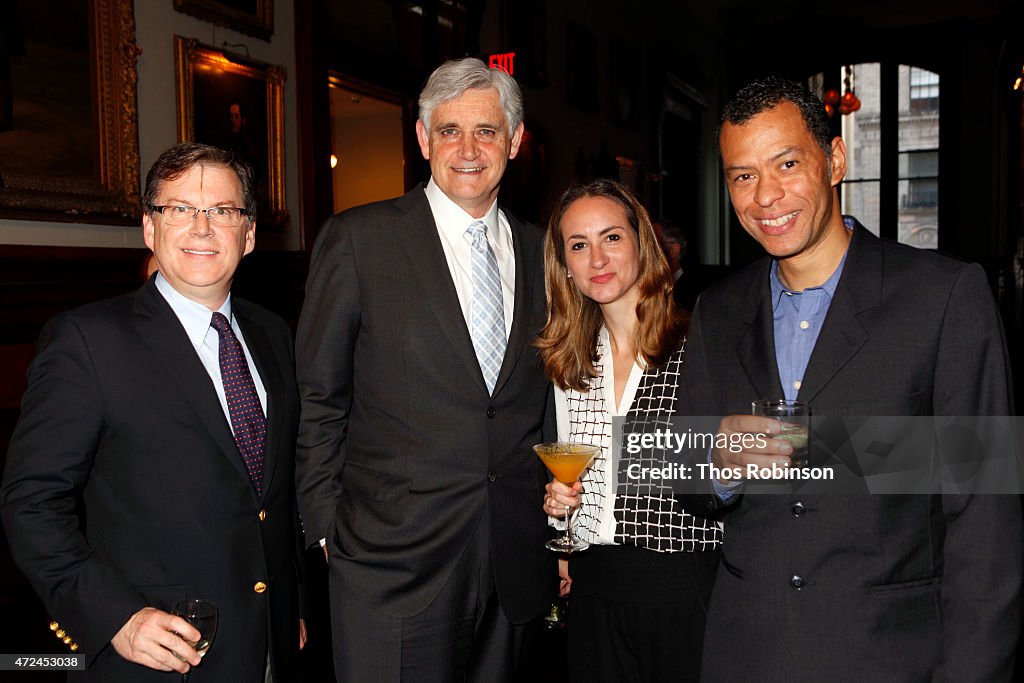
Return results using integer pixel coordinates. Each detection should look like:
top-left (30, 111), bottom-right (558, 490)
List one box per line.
top-left (174, 36), bottom-right (289, 228)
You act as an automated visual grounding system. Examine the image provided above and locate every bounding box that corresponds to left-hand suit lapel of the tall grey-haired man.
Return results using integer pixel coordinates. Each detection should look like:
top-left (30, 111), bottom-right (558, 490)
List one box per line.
top-left (395, 185), bottom-right (487, 392)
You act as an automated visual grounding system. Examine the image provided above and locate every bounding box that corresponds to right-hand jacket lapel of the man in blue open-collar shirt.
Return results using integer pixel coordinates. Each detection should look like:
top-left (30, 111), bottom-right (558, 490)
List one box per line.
top-left (798, 224), bottom-right (882, 405)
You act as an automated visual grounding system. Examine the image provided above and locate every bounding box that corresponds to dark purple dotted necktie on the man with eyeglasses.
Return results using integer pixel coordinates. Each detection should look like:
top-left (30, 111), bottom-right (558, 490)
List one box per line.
top-left (210, 313), bottom-right (266, 496)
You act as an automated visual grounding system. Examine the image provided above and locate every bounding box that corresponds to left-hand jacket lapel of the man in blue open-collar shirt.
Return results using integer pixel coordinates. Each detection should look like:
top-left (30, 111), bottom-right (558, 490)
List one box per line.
top-left (736, 259), bottom-right (783, 400)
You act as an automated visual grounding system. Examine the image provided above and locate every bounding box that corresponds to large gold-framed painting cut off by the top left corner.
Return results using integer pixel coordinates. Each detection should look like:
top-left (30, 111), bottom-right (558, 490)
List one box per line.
top-left (0, 0), bottom-right (141, 224)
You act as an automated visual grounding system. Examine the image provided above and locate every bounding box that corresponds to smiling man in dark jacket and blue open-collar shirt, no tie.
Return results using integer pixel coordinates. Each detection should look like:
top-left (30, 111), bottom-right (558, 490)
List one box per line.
top-left (683, 79), bottom-right (1021, 682)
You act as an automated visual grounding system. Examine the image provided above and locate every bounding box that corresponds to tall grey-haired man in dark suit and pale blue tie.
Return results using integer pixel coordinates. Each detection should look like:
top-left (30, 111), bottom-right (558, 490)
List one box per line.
top-left (297, 59), bottom-right (555, 683)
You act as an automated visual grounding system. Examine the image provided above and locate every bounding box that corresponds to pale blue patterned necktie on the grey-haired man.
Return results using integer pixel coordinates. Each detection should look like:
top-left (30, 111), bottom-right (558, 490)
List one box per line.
top-left (466, 220), bottom-right (507, 393)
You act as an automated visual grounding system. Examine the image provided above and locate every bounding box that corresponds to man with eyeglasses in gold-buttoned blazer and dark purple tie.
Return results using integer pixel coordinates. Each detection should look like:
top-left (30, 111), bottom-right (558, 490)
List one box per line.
top-left (0, 142), bottom-right (305, 683)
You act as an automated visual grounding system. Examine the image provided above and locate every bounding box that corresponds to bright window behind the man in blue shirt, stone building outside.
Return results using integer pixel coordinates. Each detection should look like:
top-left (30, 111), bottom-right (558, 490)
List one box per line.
top-left (811, 62), bottom-right (939, 249)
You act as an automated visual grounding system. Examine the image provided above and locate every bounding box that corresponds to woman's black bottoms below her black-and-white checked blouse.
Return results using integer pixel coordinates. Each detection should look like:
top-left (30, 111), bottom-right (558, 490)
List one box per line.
top-left (567, 545), bottom-right (720, 683)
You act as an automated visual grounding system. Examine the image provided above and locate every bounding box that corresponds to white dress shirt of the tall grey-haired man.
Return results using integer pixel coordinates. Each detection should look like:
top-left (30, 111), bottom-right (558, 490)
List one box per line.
top-left (423, 178), bottom-right (515, 338)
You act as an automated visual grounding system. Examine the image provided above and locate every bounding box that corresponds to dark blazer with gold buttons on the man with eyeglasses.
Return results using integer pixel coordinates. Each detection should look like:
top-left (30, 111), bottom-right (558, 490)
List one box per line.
top-left (0, 280), bottom-right (301, 683)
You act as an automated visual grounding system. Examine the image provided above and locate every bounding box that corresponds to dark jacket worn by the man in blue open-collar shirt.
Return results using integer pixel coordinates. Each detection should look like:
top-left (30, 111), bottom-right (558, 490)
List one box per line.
top-left (683, 225), bottom-right (1021, 681)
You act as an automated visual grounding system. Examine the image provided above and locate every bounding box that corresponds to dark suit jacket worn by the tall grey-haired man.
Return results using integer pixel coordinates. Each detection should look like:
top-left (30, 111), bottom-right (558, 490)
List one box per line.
top-left (296, 186), bottom-right (554, 623)
